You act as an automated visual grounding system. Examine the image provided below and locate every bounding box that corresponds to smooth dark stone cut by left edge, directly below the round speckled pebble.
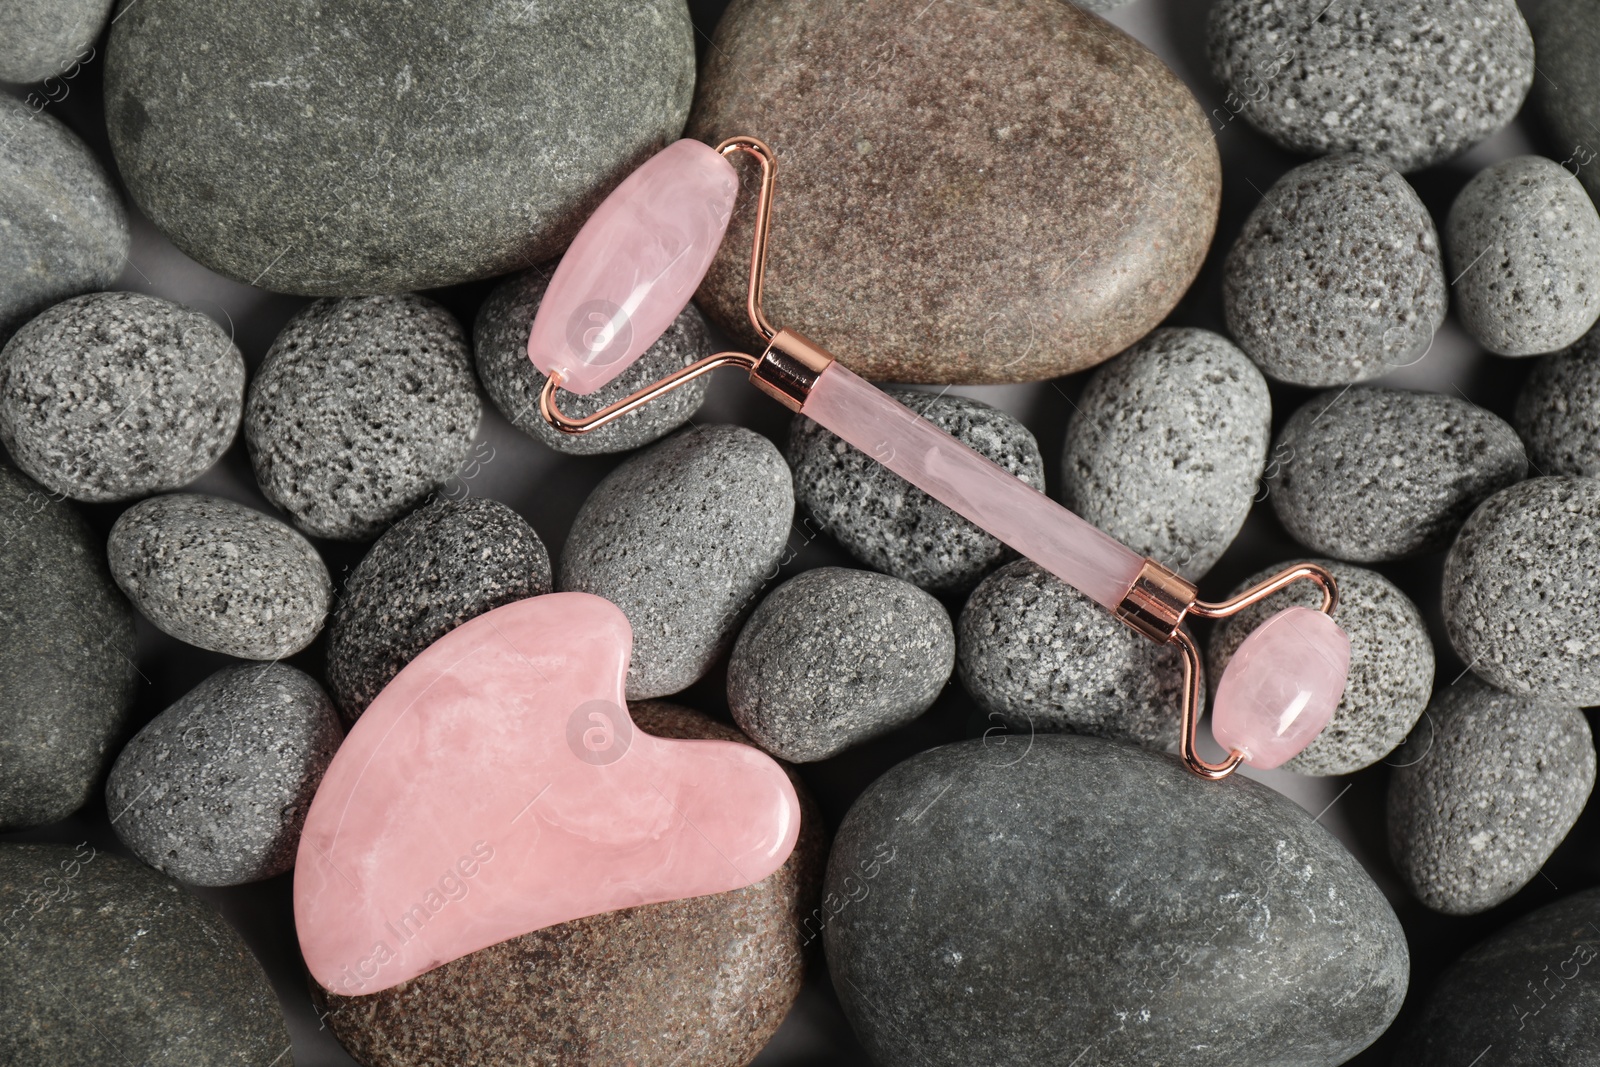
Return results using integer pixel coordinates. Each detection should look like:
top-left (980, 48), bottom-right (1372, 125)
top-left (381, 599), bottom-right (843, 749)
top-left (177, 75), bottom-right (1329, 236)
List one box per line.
top-left (0, 464), bottom-right (139, 830)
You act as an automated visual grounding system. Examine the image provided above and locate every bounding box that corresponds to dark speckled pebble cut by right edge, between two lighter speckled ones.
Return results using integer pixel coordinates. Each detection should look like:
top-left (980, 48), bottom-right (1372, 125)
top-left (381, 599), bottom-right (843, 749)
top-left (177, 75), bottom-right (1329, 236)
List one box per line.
top-left (1512, 331), bottom-right (1600, 477)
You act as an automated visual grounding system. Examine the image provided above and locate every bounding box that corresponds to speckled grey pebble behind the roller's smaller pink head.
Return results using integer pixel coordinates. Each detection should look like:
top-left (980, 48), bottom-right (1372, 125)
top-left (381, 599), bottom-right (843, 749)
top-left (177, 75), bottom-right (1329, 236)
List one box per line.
top-left (1206, 560), bottom-right (1434, 774)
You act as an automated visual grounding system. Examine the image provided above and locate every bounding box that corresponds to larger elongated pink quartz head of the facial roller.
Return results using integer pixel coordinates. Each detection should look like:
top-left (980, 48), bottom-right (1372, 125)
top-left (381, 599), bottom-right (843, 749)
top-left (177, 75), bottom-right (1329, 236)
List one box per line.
top-left (528, 139), bottom-right (739, 394)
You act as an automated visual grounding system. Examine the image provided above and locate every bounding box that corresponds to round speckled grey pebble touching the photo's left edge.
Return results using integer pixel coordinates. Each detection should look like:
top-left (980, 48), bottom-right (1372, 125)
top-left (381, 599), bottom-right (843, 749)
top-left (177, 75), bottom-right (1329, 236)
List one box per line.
top-left (0, 293), bottom-right (245, 501)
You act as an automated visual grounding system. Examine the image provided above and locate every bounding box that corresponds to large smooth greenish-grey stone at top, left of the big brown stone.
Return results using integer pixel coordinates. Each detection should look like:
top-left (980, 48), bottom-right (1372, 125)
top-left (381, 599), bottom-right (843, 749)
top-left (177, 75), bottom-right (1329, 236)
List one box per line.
top-left (106, 0), bottom-right (694, 296)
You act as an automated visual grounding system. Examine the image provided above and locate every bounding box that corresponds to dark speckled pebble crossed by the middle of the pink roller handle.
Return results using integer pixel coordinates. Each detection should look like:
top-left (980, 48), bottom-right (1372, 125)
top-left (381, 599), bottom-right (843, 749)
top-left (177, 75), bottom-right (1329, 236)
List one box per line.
top-left (789, 389), bottom-right (1045, 593)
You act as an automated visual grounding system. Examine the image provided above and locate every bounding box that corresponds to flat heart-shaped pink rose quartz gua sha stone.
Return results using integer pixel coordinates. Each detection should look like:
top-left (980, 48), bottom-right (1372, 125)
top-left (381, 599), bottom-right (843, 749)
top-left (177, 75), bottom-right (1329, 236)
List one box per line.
top-left (294, 593), bottom-right (800, 997)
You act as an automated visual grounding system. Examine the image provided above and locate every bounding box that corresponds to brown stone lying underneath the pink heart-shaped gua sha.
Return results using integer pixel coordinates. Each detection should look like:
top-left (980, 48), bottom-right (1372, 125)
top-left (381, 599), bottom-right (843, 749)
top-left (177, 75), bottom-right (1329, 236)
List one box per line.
top-left (326, 702), bottom-right (837, 1067)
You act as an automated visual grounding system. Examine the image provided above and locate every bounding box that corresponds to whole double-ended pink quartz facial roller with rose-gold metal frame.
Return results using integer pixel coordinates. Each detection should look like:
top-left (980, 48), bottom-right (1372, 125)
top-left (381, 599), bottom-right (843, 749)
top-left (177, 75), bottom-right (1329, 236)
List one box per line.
top-left (528, 138), bottom-right (1350, 779)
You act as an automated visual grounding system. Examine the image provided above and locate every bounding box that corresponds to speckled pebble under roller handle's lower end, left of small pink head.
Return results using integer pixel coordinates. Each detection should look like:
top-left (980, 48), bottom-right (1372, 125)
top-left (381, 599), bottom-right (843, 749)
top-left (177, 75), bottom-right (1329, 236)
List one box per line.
top-left (955, 560), bottom-right (1184, 749)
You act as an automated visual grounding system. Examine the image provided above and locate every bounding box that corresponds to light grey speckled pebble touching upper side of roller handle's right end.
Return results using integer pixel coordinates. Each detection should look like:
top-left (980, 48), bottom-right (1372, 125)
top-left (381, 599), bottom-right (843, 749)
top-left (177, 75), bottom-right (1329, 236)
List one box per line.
top-left (1061, 330), bottom-right (1272, 581)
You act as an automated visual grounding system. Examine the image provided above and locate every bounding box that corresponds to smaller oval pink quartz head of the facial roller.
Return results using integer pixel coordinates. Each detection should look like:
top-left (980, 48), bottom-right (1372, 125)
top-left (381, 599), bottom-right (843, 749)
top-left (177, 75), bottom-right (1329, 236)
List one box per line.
top-left (1211, 608), bottom-right (1350, 769)
